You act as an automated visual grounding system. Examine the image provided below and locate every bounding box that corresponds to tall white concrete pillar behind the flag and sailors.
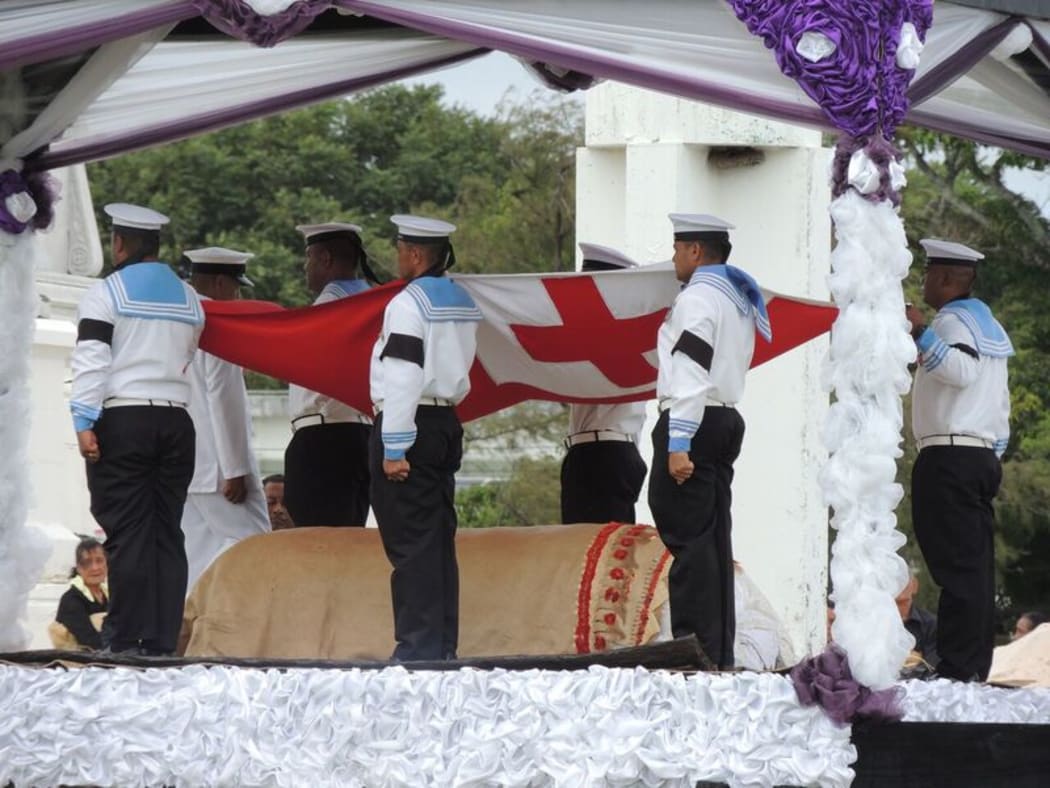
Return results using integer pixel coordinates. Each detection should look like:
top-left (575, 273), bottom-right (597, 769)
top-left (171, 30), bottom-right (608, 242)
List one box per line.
top-left (576, 83), bottom-right (831, 656)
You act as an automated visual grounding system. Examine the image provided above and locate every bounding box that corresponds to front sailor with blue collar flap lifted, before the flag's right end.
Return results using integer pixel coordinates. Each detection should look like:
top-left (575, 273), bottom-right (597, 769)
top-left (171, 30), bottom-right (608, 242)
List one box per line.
top-left (649, 213), bottom-right (771, 668)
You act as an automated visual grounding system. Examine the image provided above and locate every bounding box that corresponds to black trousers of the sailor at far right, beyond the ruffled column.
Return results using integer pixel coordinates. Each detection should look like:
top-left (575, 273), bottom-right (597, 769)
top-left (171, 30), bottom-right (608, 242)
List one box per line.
top-left (911, 447), bottom-right (1003, 681)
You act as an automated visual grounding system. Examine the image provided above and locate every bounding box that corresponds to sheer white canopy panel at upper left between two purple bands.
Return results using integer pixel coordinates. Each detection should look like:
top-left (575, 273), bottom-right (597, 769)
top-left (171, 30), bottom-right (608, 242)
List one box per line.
top-left (38, 28), bottom-right (485, 167)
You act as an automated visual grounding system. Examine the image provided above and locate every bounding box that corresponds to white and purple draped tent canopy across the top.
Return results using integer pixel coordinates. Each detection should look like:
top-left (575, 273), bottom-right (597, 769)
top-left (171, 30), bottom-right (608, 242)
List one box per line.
top-left (0, 0), bottom-right (1050, 169)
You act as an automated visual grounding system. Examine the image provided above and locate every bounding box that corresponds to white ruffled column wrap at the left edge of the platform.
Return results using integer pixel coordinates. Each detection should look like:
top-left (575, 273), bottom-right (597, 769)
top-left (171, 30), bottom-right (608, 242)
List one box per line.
top-left (0, 230), bottom-right (50, 651)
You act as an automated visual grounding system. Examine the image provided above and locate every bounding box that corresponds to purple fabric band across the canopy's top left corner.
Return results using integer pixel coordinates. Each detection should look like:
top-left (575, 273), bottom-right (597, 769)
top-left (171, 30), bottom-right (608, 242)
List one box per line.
top-left (0, 0), bottom-right (197, 71)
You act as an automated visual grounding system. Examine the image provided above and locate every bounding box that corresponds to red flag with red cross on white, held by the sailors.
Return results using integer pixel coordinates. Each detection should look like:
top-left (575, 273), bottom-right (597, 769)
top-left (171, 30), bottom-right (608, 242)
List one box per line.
top-left (201, 265), bottom-right (838, 421)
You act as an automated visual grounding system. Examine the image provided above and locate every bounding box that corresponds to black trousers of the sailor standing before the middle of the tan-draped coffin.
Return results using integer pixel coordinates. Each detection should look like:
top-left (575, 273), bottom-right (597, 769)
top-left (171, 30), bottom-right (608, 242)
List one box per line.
top-left (369, 406), bottom-right (463, 661)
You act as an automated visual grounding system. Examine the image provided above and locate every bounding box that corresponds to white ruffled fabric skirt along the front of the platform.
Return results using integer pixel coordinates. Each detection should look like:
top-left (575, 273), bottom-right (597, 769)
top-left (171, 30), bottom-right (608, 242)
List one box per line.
top-left (0, 665), bottom-right (857, 788)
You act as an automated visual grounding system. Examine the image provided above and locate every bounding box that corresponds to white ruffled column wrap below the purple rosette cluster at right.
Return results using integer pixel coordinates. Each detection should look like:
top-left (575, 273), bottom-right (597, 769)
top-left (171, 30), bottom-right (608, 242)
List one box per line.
top-left (820, 189), bottom-right (916, 689)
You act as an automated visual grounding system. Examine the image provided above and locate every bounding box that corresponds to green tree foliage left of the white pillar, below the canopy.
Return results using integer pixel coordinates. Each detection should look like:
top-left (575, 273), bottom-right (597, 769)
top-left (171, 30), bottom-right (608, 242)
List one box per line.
top-left (89, 85), bottom-right (583, 298)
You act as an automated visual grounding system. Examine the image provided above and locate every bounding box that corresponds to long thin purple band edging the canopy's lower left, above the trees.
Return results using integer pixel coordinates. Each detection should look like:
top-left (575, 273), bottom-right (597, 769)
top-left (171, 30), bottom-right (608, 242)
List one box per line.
top-left (31, 49), bottom-right (488, 170)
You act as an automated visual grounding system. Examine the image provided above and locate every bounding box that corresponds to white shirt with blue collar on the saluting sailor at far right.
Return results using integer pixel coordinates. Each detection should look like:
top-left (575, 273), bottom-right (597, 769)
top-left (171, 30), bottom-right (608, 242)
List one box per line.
top-left (911, 298), bottom-right (1013, 456)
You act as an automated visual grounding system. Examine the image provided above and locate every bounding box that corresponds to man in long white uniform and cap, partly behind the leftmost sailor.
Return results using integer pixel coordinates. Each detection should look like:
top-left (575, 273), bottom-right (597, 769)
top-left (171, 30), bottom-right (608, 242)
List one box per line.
top-left (182, 247), bottom-right (270, 594)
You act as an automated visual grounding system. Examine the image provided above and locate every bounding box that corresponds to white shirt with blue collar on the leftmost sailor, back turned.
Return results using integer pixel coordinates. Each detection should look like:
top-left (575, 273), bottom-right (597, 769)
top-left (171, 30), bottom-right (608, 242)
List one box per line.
top-left (69, 262), bottom-right (205, 432)
